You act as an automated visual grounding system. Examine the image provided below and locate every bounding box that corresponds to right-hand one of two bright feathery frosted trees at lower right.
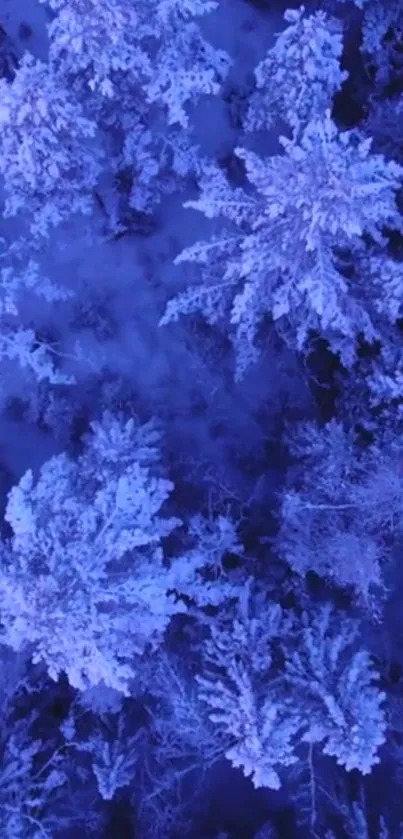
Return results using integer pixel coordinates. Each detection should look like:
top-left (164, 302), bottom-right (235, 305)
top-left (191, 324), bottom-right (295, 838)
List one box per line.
top-left (285, 604), bottom-right (386, 775)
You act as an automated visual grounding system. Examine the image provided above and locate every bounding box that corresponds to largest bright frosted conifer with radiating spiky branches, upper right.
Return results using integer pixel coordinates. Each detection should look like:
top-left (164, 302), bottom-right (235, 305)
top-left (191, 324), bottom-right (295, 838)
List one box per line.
top-left (161, 113), bottom-right (403, 375)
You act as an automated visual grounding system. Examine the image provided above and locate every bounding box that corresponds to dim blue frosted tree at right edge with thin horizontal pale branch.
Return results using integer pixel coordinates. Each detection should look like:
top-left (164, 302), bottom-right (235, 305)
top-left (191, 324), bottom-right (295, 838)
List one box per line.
top-left (277, 420), bottom-right (403, 608)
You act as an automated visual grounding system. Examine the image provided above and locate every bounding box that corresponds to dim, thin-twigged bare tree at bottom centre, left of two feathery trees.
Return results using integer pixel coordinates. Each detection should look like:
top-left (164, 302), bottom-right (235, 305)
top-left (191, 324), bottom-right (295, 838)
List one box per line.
top-left (133, 651), bottom-right (228, 837)
